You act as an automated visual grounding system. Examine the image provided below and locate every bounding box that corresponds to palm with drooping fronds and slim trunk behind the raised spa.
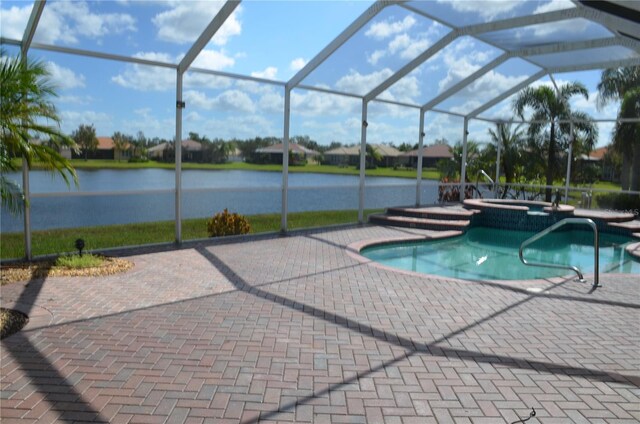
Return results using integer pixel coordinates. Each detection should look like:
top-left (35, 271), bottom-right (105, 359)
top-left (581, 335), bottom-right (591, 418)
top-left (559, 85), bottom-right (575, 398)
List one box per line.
top-left (513, 82), bottom-right (598, 202)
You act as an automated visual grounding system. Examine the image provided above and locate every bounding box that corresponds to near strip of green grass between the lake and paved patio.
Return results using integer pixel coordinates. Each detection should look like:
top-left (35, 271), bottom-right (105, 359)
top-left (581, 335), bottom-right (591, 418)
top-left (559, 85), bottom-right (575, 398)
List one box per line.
top-left (0, 210), bottom-right (380, 259)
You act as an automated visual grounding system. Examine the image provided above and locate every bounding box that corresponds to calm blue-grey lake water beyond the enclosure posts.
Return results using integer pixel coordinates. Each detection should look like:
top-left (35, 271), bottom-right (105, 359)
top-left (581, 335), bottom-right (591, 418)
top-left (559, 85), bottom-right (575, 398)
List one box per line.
top-left (1, 169), bottom-right (437, 232)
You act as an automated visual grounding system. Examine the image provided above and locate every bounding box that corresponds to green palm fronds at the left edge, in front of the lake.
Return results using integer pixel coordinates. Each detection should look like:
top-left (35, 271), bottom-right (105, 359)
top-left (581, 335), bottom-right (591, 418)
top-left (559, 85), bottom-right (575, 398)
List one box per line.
top-left (0, 51), bottom-right (77, 214)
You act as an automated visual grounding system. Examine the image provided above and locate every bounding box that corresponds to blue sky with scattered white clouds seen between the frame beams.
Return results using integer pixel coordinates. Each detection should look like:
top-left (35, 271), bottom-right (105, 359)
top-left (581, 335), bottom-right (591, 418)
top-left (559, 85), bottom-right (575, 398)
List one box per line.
top-left (0, 0), bottom-right (626, 149)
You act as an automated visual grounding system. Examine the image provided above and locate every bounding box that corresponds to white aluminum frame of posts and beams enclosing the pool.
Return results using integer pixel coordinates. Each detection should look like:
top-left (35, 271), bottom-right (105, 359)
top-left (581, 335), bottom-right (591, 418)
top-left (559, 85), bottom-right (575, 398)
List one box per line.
top-left (5, 0), bottom-right (640, 259)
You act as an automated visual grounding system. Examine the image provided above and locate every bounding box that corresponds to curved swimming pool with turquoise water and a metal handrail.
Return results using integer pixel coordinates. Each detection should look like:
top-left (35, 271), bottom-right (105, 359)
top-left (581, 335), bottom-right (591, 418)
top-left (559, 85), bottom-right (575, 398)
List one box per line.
top-left (360, 227), bottom-right (640, 280)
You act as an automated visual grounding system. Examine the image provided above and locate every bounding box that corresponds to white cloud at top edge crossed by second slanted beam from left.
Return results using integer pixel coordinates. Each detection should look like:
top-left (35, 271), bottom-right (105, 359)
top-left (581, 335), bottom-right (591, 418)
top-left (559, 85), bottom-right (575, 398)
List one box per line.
top-left (152, 1), bottom-right (242, 46)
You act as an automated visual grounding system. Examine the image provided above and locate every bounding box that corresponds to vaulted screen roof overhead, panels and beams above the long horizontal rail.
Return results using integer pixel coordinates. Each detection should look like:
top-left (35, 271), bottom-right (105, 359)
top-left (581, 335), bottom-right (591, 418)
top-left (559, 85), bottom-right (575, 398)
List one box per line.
top-left (1, 0), bottom-right (640, 126)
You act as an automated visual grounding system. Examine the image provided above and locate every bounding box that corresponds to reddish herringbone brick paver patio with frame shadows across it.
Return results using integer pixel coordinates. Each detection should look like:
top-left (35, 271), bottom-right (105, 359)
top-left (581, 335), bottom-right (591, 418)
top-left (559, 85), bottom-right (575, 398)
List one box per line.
top-left (0, 226), bottom-right (640, 424)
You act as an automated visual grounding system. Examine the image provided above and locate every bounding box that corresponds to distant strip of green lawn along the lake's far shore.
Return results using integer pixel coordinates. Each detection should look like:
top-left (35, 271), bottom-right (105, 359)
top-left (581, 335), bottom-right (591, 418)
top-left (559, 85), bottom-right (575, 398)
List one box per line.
top-left (23, 159), bottom-right (440, 180)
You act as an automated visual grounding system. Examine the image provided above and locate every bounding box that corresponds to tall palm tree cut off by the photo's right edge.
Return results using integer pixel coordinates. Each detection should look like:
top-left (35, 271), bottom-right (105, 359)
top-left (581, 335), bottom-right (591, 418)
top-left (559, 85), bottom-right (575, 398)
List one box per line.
top-left (598, 66), bottom-right (640, 190)
